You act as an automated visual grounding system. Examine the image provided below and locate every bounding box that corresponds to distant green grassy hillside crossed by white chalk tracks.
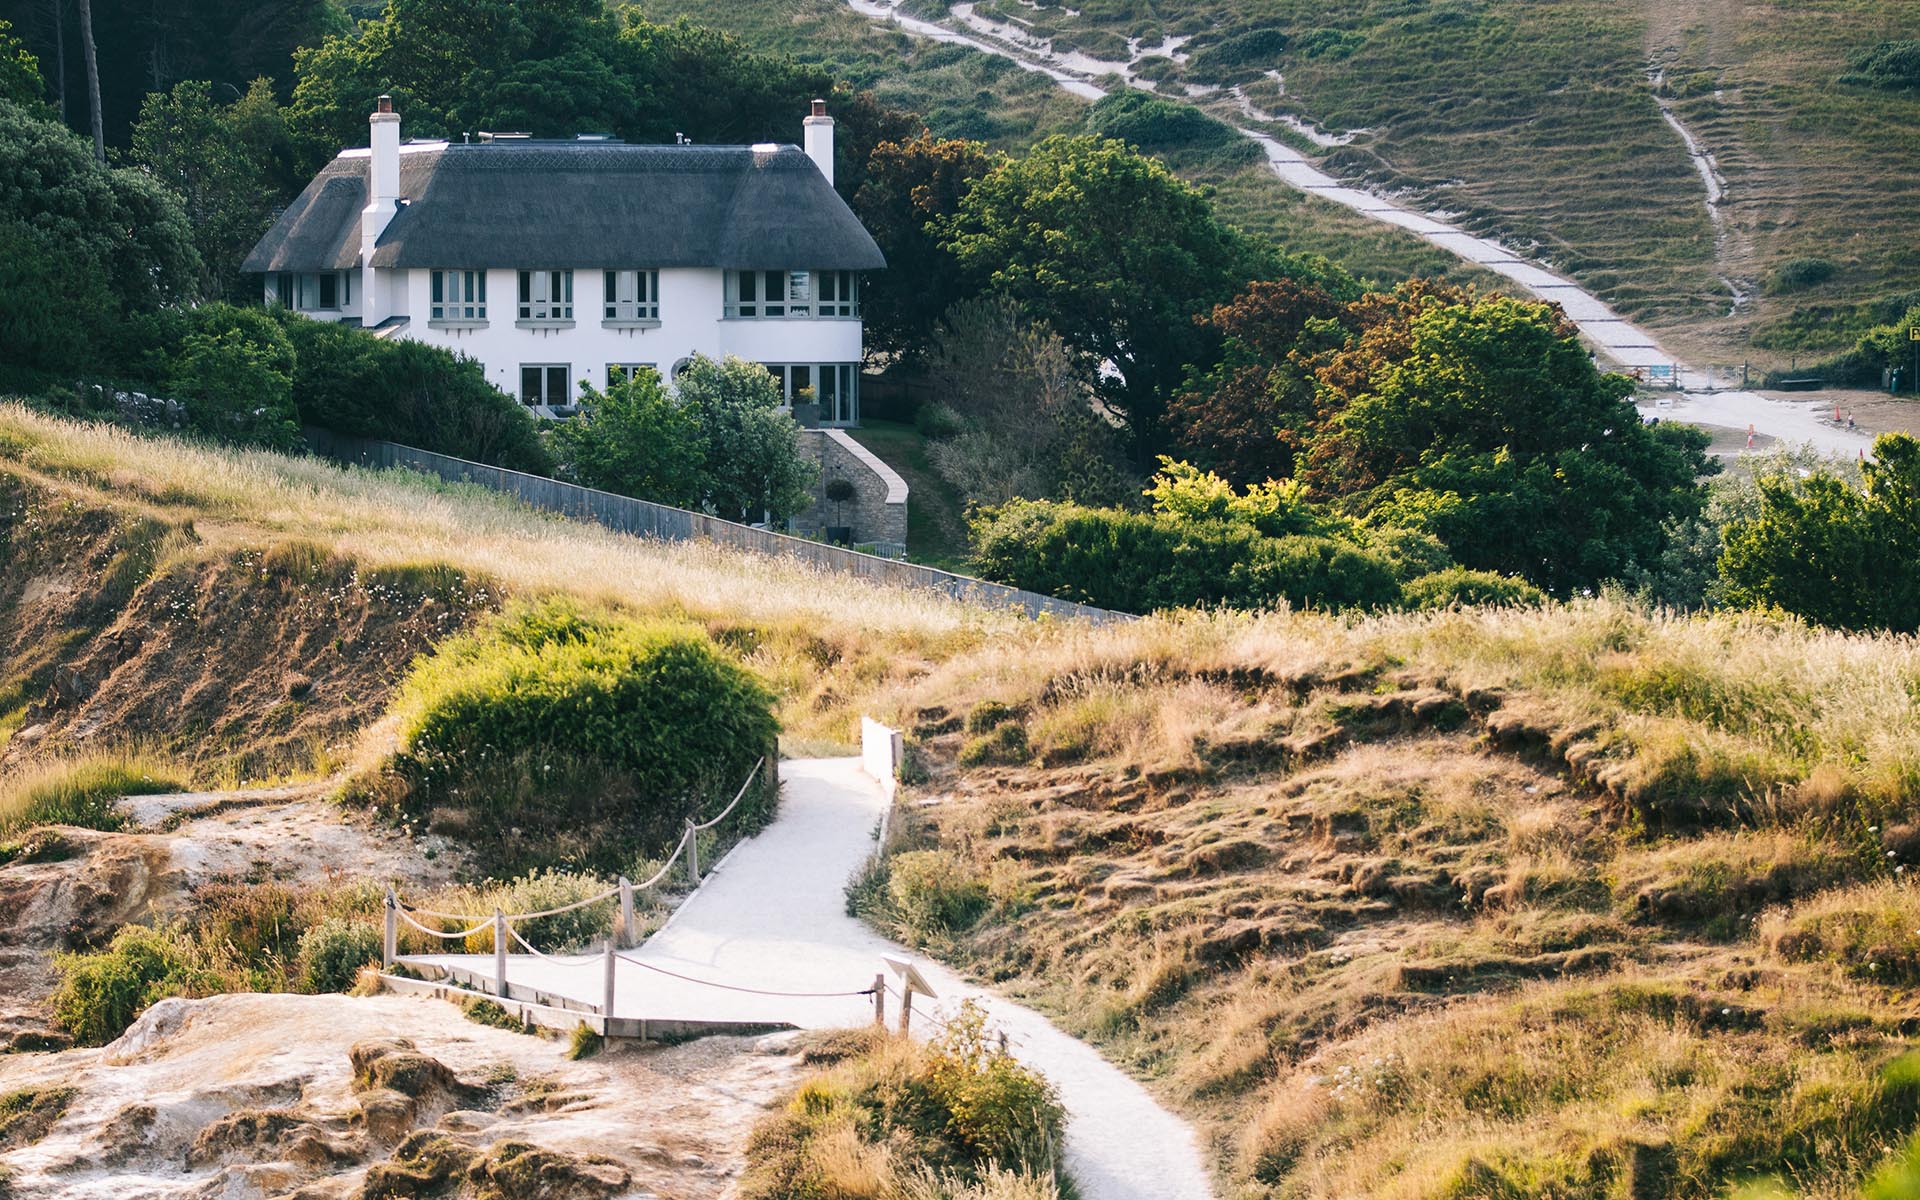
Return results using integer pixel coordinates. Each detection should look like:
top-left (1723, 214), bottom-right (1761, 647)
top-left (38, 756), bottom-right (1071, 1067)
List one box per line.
top-left (643, 0), bottom-right (1920, 365)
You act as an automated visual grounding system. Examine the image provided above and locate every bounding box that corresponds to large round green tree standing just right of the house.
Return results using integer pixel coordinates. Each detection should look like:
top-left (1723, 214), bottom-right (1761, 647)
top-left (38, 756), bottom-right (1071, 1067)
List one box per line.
top-left (945, 134), bottom-right (1281, 459)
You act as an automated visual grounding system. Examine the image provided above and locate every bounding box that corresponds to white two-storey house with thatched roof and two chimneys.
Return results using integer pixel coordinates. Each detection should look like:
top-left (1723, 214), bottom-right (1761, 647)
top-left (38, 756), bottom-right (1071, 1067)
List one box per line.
top-left (242, 96), bottom-right (885, 426)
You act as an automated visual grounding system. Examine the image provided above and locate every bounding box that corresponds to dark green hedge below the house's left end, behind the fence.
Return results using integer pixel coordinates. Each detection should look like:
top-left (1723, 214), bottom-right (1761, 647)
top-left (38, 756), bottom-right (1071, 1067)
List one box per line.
top-left (276, 309), bottom-right (553, 474)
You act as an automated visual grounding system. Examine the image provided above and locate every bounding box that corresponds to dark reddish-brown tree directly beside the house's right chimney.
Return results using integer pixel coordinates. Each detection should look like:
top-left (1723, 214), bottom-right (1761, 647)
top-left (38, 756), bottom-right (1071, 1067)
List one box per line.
top-left (851, 131), bottom-right (996, 363)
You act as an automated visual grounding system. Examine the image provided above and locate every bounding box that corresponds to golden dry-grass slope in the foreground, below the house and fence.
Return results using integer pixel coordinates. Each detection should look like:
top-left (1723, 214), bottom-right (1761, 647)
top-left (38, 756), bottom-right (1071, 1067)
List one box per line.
top-left (11, 407), bottom-right (1920, 1200)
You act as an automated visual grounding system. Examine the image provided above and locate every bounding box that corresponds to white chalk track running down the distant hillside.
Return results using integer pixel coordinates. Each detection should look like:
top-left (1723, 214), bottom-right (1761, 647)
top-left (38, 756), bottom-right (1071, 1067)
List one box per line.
top-left (847, 0), bottom-right (1872, 459)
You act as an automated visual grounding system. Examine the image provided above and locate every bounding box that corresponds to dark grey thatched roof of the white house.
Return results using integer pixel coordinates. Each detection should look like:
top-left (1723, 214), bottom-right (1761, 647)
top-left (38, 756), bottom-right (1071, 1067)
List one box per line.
top-left (240, 142), bottom-right (887, 271)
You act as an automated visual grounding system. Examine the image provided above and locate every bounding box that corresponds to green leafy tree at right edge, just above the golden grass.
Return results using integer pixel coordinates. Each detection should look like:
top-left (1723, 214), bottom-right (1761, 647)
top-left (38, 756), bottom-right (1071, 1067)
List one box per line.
top-left (1720, 434), bottom-right (1920, 634)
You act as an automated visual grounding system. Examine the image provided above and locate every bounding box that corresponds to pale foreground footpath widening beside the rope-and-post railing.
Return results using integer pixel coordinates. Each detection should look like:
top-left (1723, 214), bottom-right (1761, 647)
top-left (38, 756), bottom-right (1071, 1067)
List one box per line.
top-left (409, 758), bottom-right (1213, 1200)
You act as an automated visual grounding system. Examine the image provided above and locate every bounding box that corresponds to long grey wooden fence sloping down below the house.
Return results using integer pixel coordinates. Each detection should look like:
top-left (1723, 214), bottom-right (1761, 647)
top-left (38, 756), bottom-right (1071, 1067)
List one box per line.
top-left (305, 428), bottom-right (1131, 622)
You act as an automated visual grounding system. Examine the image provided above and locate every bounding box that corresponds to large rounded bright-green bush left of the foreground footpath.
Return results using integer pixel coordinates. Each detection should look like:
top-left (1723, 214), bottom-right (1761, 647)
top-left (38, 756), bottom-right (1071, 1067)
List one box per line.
top-left (374, 601), bottom-right (778, 872)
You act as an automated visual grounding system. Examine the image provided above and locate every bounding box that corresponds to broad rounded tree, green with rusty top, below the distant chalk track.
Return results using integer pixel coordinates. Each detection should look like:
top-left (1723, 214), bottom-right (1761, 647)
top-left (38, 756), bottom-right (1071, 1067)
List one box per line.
top-left (1302, 292), bottom-right (1711, 589)
